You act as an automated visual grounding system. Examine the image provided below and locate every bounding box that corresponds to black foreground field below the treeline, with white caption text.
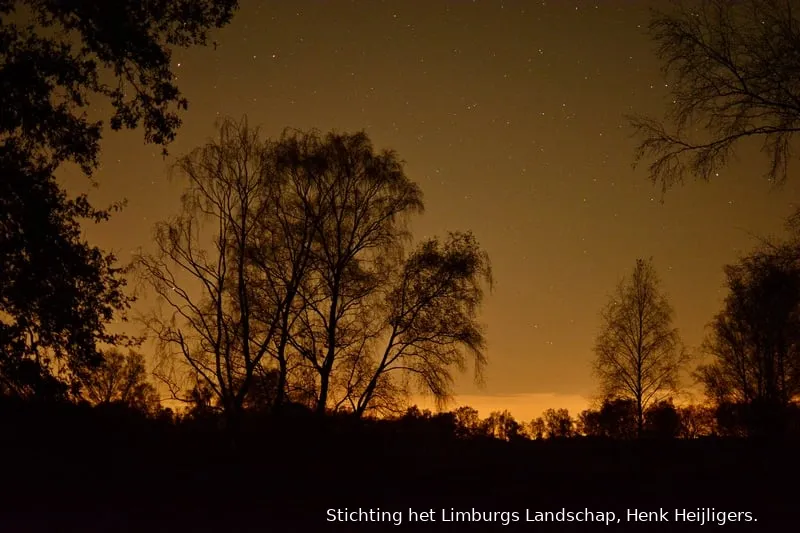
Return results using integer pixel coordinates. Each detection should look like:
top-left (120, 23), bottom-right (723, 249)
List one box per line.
top-left (0, 404), bottom-right (800, 533)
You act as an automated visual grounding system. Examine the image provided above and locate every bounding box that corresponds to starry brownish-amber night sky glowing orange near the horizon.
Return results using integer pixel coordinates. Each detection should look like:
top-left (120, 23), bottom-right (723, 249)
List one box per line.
top-left (62, 0), bottom-right (800, 420)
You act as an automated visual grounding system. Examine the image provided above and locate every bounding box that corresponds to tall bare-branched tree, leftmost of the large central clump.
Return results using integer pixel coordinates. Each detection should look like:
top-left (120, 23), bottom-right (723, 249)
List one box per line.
top-left (136, 119), bottom-right (288, 423)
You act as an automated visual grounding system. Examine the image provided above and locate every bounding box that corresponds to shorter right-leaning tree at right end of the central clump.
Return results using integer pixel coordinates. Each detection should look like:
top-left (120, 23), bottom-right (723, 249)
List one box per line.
top-left (355, 233), bottom-right (492, 415)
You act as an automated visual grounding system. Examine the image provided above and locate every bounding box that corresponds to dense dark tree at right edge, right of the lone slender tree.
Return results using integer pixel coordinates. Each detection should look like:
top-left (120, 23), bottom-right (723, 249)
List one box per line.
top-left (697, 245), bottom-right (800, 431)
